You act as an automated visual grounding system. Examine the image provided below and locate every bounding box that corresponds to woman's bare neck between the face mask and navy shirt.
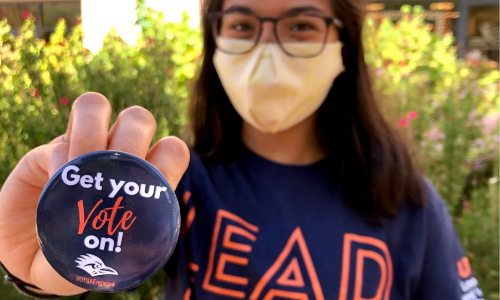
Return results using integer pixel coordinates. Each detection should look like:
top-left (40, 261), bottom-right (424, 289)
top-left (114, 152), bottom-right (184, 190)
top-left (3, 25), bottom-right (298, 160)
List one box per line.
top-left (241, 113), bottom-right (328, 165)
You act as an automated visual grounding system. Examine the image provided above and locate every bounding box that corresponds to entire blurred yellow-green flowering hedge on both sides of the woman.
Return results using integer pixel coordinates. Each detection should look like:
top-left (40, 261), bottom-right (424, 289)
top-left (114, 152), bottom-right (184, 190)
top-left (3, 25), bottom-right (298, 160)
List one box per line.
top-left (0, 1), bottom-right (499, 300)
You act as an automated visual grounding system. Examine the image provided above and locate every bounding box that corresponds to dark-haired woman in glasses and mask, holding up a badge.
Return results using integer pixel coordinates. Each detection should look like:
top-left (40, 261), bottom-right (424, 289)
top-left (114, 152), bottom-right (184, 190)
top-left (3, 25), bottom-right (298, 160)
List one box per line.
top-left (0, 0), bottom-right (482, 300)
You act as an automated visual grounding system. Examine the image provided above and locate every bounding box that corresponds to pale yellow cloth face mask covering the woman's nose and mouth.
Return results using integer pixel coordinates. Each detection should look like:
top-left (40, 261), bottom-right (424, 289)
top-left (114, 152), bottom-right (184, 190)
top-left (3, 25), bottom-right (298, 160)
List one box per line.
top-left (213, 38), bottom-right (345, 133)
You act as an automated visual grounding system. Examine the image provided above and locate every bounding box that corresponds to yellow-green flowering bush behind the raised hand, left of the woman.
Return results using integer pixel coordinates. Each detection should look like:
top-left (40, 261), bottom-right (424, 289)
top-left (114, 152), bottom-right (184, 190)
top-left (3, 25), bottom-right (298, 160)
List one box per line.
top-left (0, 0), bottom-right (202, 300)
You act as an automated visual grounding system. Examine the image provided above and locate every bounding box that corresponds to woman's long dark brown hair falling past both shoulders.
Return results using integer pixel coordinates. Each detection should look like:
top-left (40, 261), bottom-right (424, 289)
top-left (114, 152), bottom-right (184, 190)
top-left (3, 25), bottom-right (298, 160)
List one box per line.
top-left (190, 0), bottom-right (424, 221)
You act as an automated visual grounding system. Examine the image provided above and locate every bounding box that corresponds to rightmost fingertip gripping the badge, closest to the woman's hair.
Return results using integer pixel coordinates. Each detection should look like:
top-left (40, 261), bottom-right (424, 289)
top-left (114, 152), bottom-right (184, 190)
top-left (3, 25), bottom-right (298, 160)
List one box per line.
top-left (146, 136), bottom-right (189, 190)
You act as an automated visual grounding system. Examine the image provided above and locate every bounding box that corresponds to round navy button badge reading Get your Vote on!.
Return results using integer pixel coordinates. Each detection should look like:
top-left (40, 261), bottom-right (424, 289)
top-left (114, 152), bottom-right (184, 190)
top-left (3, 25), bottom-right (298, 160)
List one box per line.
top-left (36, 151), bottom-right (180, 292)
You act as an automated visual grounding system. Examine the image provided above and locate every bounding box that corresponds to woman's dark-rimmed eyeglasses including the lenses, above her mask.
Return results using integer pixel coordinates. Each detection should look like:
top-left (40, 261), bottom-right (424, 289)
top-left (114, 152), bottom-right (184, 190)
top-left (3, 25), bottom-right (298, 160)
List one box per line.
top-left (208, 8), bottom-right (343, 58)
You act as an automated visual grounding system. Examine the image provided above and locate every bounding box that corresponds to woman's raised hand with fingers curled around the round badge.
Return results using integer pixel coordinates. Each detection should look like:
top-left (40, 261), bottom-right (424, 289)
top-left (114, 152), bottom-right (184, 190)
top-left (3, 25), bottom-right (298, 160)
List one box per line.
top-left (0, 93), bottom-right (189, 295)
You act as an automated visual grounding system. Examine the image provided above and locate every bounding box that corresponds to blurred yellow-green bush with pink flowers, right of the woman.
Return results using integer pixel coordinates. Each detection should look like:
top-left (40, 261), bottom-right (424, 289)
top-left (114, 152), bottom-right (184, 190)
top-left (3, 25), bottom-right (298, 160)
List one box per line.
top-left (364, 6), bottom-right (500, 299)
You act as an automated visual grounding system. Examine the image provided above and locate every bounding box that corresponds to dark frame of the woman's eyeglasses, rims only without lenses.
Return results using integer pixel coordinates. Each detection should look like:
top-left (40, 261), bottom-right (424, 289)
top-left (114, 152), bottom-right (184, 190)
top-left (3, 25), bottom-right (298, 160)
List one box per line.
top-left (208, 9), bottom-right (344, 58)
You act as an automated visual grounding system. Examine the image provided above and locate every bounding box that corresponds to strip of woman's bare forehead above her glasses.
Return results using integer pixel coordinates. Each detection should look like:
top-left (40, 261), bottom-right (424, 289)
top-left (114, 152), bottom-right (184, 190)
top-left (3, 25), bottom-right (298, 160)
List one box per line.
top-left (222, 0), bottom-right (333, 17)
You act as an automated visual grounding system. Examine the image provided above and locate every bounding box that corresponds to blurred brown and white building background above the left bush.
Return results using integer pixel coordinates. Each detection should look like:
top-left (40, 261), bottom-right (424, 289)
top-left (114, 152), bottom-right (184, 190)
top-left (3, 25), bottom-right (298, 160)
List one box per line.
top-left (0, 0), bottom-right (199, 53)
